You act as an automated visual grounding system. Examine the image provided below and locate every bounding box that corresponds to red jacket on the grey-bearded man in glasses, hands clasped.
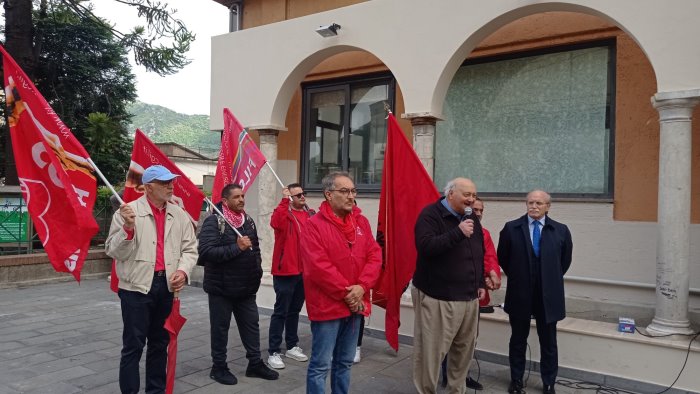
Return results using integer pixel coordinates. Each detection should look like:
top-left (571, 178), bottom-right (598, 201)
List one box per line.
top-left (301, 202), bottom-right (382, 321)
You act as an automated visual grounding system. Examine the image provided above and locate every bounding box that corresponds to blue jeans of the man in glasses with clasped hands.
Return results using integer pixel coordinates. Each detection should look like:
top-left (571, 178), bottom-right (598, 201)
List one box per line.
top-left (306, 314), bottom-right (362, 394)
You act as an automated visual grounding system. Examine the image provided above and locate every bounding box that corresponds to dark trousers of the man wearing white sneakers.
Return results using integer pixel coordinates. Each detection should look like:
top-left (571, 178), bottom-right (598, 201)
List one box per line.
top-left (268, 274), bottom-right (304, 355)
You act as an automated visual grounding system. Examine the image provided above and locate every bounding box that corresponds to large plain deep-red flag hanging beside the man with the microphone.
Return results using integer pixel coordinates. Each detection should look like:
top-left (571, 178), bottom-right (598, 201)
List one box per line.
top-left (373, 114), bottom-right (440, 351)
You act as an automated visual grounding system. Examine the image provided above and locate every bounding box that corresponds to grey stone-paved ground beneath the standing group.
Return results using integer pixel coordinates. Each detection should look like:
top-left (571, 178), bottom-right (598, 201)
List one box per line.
top-left (0, 279), bottom-right (578, 394)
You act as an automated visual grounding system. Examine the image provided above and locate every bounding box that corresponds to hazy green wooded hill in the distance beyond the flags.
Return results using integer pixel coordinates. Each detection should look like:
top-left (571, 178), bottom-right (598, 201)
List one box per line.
top-left (128, 101), bottom-right (221, 158)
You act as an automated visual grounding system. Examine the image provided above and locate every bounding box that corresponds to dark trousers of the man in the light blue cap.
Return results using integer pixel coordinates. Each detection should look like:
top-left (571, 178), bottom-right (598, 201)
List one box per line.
top-left (118, 276), bottom-right (173, 394)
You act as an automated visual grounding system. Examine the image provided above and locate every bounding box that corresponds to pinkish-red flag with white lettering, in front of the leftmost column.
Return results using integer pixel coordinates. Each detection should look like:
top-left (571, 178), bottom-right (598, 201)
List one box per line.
top-left (211, 108), bottom-right (267, 201)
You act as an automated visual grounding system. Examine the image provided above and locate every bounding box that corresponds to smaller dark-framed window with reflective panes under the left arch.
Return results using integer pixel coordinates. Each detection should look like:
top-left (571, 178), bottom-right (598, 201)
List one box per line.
top-left (301, 76), bottom-right (394, 191)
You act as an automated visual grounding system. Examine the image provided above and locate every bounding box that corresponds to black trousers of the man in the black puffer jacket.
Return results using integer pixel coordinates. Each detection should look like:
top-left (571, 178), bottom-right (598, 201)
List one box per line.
top-left (208, 294), bottom-right (262, 367)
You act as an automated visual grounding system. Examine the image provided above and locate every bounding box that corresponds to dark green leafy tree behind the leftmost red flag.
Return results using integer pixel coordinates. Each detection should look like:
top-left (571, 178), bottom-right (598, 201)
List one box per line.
top-left (35, 5), bottom-right (136, 182)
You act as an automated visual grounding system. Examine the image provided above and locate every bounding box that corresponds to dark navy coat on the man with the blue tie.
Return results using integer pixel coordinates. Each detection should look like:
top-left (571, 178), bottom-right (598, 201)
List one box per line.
top-left (497, 215), bottom-right (573, 323)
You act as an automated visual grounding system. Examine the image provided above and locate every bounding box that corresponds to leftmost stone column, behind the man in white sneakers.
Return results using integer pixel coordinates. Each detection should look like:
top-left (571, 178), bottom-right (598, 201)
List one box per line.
top-left (255, 129), bottom-right (279, 273)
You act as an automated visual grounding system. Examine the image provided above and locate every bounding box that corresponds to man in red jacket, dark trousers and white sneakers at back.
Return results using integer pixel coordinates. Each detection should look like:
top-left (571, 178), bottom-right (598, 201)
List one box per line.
top-left (267, 183), bottom-right (315, 369)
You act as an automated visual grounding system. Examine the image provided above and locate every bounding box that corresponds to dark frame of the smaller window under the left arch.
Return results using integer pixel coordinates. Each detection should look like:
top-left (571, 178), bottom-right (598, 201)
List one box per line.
top-left (299, 72), bottom-right (396, 195)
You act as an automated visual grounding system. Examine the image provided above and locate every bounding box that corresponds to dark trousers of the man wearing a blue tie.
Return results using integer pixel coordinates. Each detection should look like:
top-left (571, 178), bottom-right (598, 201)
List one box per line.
top-left (508, 286), bottom-right (559, 385)
